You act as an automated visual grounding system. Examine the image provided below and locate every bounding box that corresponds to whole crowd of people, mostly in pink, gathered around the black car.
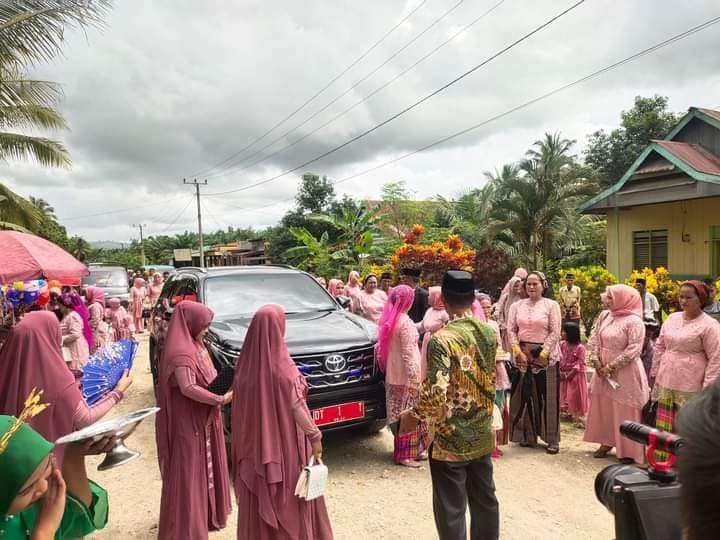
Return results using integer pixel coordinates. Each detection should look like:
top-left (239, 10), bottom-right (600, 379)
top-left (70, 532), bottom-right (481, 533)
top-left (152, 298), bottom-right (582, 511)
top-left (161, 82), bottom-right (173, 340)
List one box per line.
top-left (0, 260), bottom-right (720, 539)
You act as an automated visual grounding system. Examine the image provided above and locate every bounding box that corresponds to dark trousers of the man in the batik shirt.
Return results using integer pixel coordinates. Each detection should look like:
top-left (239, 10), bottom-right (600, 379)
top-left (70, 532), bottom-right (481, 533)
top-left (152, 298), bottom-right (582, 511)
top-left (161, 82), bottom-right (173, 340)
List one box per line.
top-left (430, 454), bottom-right (500, 540)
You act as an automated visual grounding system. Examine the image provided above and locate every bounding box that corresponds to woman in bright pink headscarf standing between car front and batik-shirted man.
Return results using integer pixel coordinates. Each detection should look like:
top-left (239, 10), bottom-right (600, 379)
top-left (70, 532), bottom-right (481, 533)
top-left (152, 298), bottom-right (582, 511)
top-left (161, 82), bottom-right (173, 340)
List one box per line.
top-left (377, 285), bottom-right (422, 468)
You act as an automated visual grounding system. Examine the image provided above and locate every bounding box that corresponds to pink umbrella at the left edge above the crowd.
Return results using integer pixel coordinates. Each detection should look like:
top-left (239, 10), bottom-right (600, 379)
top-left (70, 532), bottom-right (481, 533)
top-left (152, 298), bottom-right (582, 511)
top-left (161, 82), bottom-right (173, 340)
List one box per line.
top-left (0, 231), bottom-right (88, 285)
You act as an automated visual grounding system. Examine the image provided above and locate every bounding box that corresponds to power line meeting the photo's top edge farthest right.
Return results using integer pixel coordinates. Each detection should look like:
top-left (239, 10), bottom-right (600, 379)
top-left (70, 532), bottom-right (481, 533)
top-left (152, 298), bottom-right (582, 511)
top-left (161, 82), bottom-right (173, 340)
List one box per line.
top-left (207, 0), bottom-right (585, 197)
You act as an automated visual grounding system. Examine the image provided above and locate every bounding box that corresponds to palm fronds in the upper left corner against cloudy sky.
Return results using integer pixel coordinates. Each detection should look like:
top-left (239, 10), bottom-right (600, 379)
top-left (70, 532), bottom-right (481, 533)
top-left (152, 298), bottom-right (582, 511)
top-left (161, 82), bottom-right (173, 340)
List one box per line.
top-left (0, 0), bottom-right (110, 167)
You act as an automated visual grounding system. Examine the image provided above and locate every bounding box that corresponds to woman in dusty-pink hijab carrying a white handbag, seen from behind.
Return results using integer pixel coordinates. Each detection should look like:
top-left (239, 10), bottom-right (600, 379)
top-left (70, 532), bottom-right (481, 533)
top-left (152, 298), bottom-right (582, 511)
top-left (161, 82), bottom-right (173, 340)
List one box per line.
top-left (232, 305), bottom-right (333, 540)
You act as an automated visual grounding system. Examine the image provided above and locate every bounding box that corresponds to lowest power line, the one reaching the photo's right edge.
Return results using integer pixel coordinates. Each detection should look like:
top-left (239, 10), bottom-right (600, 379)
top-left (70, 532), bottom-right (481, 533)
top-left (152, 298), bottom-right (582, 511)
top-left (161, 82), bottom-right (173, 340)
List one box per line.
top-left (217, 16), bottom-right (720, 212)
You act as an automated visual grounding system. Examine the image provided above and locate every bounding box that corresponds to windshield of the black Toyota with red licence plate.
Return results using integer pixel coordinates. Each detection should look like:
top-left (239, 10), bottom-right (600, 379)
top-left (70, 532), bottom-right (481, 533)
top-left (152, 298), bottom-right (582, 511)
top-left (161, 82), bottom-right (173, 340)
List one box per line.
top-left (205, 273), bottom-right (337, 319)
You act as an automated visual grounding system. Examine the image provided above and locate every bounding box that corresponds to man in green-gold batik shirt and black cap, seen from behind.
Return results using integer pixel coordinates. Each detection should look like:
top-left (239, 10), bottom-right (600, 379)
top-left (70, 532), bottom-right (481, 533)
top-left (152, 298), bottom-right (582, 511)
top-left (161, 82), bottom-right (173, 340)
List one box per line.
top-left (400, 270), bottom-right (499, 540)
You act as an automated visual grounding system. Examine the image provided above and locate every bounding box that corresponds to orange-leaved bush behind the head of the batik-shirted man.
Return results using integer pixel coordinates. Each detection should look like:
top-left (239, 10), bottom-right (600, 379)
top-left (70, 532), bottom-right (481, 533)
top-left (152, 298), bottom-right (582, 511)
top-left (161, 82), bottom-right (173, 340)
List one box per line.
top-left (390, 225), bottom-right (475, 285)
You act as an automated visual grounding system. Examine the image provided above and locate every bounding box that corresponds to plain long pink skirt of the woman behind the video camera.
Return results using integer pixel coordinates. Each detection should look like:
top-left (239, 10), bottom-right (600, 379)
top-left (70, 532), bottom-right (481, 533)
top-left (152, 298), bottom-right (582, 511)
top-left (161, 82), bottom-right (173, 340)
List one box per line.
top-left (583, 396), bottom-right (645, 464)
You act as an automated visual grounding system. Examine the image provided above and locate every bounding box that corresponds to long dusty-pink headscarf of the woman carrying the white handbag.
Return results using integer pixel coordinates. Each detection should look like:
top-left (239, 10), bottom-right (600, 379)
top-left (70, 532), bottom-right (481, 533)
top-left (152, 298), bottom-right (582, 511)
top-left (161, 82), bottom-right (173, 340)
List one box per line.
top-left (231, 304), bottom-right (307, 528)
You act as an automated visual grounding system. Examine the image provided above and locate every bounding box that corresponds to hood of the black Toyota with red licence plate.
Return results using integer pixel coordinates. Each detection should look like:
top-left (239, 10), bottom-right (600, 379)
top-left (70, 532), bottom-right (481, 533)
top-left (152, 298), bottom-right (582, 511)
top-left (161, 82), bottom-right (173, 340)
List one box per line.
top-left (211, 310), bottom-right (377, 356)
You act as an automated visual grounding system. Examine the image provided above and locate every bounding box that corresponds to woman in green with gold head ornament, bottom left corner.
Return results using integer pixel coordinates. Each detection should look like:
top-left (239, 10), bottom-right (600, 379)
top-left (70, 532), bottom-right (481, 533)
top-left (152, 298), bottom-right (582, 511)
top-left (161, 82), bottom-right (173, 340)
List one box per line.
top-left (0, 408), bottom-right (115, 540)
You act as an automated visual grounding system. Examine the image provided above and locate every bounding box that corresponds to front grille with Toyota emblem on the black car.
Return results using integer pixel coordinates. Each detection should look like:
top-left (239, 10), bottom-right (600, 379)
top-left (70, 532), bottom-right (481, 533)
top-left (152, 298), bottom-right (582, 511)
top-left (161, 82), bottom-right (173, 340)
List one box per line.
top-left (293, 347), bottom-right (376, 389)
